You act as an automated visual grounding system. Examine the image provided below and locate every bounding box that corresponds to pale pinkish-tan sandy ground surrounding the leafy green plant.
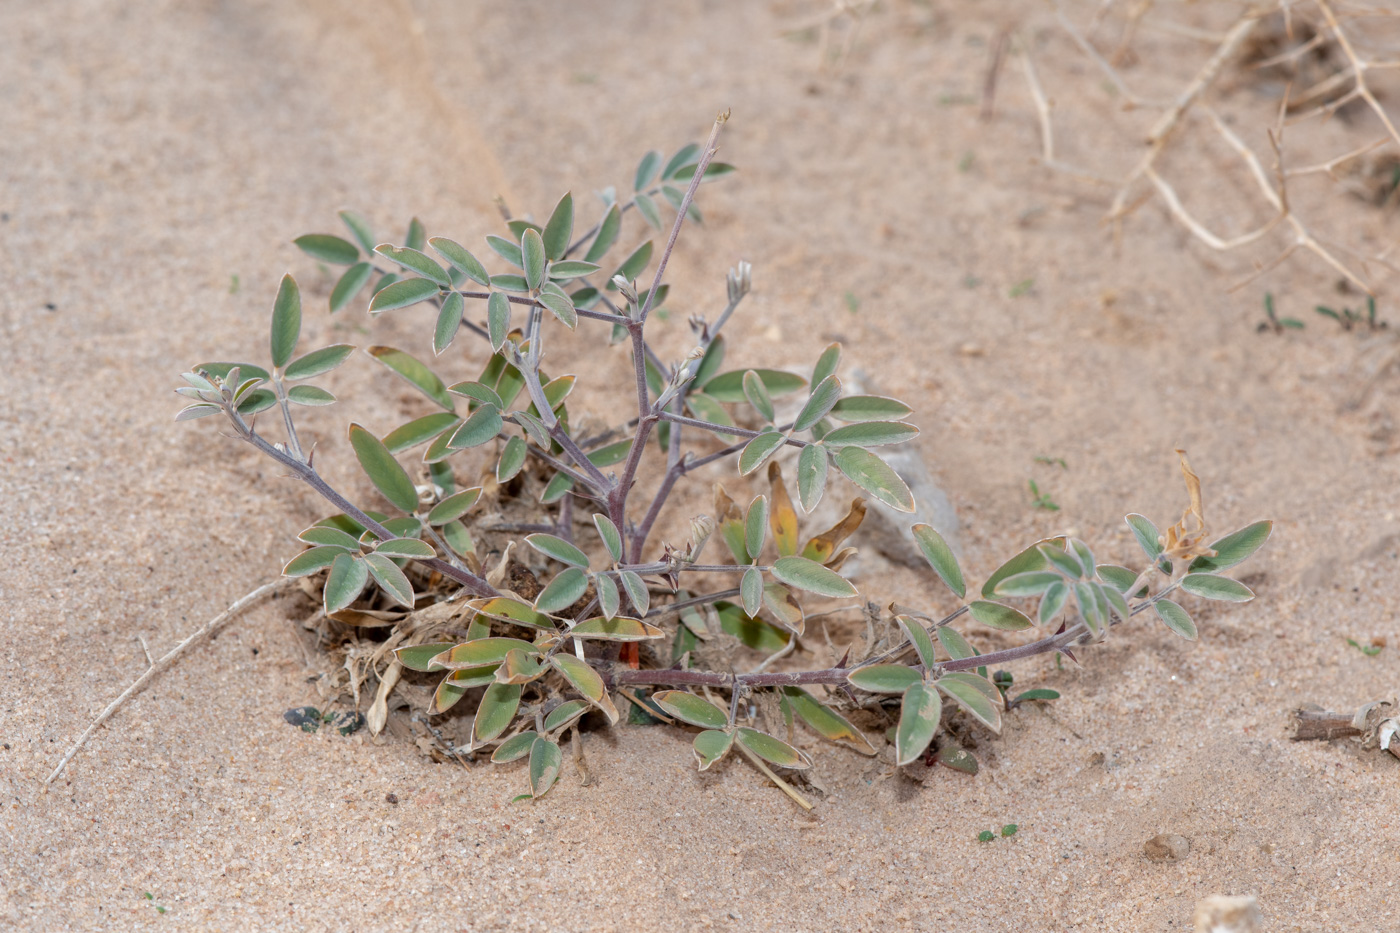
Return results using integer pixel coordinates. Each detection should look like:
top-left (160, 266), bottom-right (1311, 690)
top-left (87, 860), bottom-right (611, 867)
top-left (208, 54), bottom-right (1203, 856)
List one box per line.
top-left (0, 0), bottom-right (1400, 930)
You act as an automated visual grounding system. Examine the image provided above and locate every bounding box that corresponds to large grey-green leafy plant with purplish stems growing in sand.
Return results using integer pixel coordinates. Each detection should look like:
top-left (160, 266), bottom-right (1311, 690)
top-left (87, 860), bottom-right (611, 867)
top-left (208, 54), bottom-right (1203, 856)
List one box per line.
top-left (176, 118), bottom-right (1270, 800)
